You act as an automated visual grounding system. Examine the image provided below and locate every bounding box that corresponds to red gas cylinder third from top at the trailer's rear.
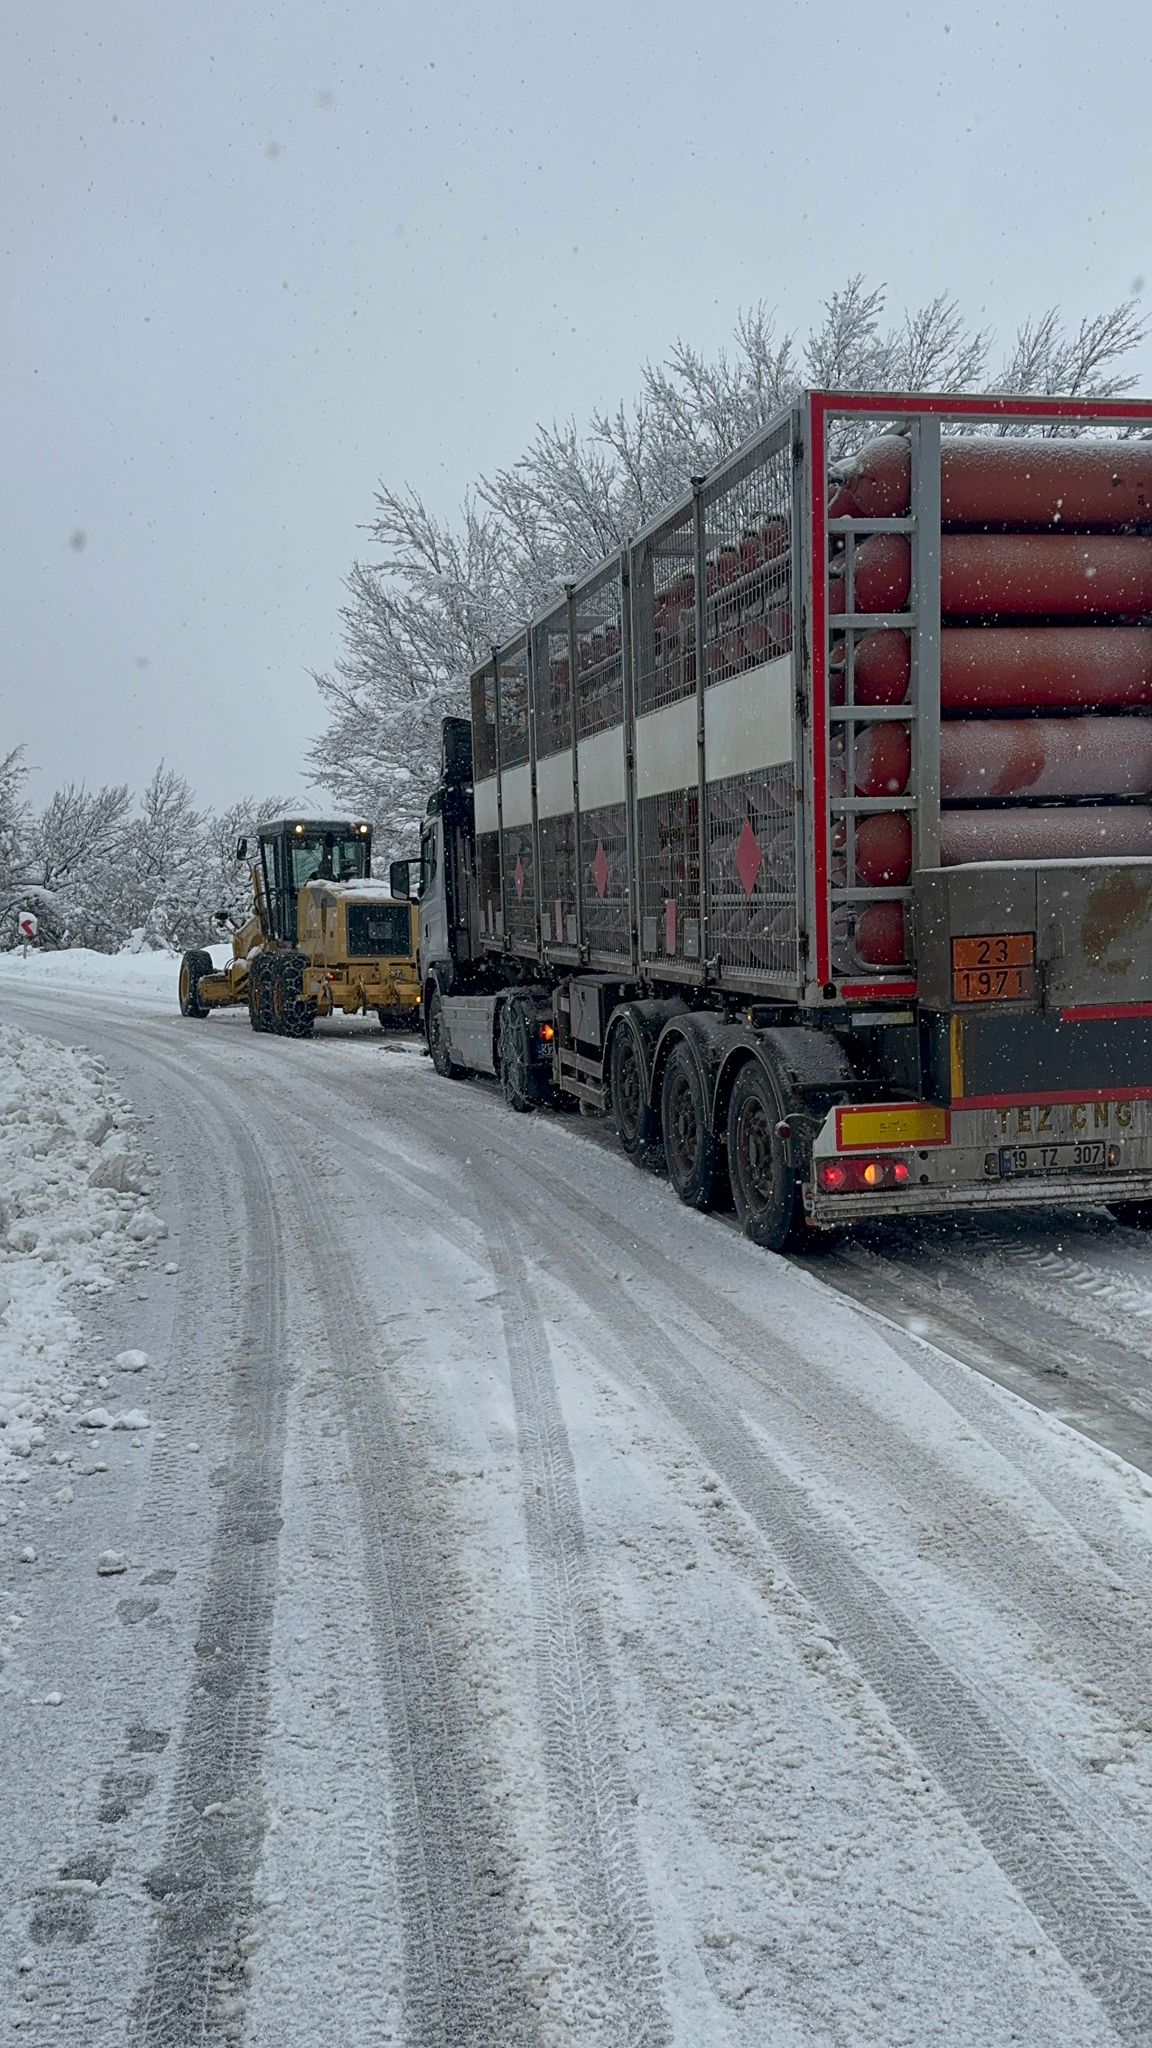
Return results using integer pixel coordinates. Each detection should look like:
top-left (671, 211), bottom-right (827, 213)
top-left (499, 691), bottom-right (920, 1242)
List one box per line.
top-left (832, 627), bottom-right (1152, 711)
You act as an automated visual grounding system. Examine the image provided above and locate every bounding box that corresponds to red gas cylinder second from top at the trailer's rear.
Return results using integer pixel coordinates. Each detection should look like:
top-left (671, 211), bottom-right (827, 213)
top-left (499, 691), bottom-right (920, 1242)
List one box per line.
top-left (828, 532), bottom-right (1152, 618)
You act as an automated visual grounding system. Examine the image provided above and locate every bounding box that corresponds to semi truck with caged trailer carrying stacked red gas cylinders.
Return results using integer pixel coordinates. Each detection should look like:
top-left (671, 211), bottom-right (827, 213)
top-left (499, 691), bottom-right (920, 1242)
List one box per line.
top-left (396, 391), bottom-right (1152, 1249)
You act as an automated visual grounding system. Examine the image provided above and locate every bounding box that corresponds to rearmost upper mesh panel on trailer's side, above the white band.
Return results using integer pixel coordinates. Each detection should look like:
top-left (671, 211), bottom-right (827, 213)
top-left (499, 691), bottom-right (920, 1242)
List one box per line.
top-left (701, 434), bottom-right (793, 684)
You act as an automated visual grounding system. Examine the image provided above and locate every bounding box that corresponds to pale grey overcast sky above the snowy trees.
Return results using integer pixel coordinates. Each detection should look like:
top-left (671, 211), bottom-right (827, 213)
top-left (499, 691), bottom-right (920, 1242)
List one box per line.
top-left (0, 0), bottom-right (1152, 803)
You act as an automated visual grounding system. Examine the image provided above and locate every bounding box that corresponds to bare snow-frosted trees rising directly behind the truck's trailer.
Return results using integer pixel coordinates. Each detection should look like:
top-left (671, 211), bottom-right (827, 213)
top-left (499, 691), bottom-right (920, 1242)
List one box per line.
top-left (310, 276), bottom-right (1146, 827)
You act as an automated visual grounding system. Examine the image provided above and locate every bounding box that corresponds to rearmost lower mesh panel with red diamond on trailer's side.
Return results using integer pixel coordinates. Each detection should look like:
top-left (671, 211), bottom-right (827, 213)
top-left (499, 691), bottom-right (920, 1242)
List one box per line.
top-left (707, 764), bottom-right (799, 981)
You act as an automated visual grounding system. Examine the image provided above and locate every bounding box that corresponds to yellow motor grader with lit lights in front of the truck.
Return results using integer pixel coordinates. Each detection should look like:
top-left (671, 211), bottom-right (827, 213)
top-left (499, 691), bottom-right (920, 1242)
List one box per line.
top-left (180, 817), bottom-right (420, 1038)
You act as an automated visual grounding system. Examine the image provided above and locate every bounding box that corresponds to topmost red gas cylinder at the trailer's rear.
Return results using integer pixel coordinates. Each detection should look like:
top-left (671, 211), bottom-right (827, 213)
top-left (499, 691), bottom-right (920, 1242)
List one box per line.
top-left (828, 434), bottom-right (1152, 528)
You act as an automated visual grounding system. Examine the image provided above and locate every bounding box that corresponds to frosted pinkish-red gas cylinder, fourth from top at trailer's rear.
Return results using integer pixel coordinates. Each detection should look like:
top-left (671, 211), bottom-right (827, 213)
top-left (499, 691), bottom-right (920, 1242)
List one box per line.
top-left (938, 719), bottom-right (1152, 801)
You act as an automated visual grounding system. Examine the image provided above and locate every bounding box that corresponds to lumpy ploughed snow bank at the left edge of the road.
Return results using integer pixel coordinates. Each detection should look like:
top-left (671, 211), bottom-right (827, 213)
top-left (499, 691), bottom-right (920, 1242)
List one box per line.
top-left (0, 1024), bottom-right (166, 1479)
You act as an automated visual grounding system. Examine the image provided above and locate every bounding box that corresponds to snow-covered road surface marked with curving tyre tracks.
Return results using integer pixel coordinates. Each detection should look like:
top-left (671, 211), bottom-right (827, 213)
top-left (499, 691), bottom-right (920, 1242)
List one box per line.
top-left (0, 961), bottom-right (1152, 2048)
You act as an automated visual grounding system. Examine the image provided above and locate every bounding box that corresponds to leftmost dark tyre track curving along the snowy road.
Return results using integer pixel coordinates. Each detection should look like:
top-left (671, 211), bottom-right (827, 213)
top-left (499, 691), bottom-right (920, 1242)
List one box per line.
top-left (1, 1001), bottom-right (295, 2048)
